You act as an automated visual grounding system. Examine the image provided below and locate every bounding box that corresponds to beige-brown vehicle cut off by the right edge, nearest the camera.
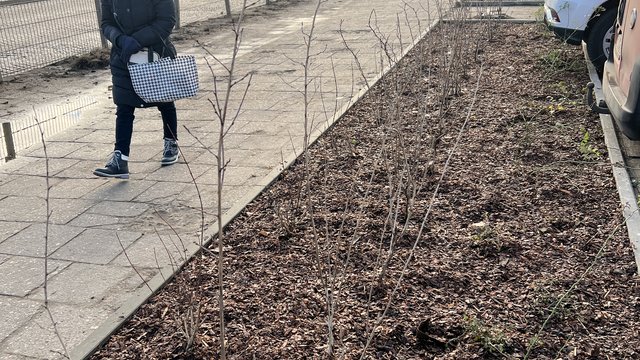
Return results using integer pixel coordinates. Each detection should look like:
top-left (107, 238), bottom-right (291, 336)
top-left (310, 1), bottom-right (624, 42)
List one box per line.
top-left (602, 0), bottom-right (640, 140)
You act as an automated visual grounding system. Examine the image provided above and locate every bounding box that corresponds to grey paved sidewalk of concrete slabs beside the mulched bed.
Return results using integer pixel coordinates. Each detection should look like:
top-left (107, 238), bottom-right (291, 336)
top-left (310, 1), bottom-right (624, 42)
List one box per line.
top-left (0, 0), bottom-right (536, 359)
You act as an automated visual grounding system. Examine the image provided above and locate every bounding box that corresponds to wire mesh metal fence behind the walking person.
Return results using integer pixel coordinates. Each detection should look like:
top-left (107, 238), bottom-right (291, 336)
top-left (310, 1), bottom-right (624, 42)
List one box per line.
top-left (0, 0), bottom-right (273, 81)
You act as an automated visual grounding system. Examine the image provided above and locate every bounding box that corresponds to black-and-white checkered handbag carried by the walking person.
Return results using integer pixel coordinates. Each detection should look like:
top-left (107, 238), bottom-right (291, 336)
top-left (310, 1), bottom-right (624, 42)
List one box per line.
top-left (128, 55), bottom-right (198, 103)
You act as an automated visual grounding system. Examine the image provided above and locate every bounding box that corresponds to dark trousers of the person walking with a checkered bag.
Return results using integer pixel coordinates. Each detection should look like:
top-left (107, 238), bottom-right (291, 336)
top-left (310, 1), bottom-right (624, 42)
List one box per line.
top-left (115, 102), bottom-right (178, 156)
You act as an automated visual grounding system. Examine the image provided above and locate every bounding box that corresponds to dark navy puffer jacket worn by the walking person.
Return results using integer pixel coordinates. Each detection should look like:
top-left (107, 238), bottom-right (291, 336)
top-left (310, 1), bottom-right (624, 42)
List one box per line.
top-left (100, 0), bottom-right (176, 107)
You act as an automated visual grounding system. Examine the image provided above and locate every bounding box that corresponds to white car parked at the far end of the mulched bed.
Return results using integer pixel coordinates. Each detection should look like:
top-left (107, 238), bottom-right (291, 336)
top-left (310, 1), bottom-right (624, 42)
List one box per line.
top-left (544, 0), bottom-right (620, 72)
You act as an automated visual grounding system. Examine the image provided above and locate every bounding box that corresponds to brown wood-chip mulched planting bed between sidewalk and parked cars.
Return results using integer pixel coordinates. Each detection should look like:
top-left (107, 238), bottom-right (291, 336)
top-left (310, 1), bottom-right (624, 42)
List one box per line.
top-left (93, 22), bottom-right (640, 359)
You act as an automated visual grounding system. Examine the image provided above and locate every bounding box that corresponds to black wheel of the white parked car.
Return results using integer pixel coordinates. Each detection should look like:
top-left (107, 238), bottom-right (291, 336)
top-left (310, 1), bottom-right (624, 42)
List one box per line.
top-left (585, 9), bottom-right (617, 72)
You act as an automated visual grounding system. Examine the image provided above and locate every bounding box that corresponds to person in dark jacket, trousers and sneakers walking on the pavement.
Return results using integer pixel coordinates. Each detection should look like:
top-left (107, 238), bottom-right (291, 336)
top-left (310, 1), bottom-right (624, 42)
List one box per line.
top-left (93, 0), bottom-right (179, 179)
